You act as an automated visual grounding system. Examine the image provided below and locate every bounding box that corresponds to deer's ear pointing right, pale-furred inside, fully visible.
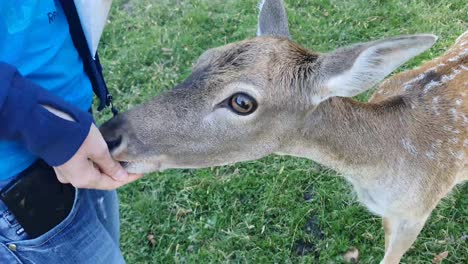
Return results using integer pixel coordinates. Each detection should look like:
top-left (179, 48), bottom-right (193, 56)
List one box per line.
top-left (315, 34), bottom-right (437, 101)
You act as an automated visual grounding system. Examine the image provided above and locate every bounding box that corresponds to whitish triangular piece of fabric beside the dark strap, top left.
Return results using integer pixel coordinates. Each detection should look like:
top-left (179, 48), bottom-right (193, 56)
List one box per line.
top-left (74, 0), bottom-right (112, 58)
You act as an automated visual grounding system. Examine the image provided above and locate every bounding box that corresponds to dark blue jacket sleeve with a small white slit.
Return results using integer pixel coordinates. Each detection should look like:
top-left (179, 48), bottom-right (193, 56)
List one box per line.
top-left (0, 62), bottom-right (93, 166)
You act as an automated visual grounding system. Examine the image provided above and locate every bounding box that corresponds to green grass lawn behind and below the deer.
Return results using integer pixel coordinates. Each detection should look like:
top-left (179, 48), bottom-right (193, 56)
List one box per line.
top-left (98, 0), bottom-right (468, 263)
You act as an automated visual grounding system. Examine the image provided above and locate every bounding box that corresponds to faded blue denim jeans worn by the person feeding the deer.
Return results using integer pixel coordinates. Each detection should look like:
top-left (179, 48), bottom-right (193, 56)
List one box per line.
top-left (0, 189), bottom-right (125, 264)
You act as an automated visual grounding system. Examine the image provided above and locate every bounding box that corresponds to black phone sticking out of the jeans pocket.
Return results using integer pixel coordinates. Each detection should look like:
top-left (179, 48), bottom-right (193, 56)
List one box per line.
top-left (0, 161), bottom-right (75, 238)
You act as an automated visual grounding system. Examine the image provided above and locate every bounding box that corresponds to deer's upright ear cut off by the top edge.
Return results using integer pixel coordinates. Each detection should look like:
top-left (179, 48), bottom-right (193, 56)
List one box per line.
top-left (257, 0), bottom-right (291, 39)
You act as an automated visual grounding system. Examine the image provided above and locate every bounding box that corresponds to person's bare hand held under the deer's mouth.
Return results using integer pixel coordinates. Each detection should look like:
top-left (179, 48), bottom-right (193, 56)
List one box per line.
top-left (54, 124), bottom-right (143, 190)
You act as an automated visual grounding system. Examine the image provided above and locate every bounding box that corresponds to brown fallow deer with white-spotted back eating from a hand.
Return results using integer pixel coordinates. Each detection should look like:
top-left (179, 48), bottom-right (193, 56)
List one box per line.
top-left (100, 0), bottom-right (468, 264)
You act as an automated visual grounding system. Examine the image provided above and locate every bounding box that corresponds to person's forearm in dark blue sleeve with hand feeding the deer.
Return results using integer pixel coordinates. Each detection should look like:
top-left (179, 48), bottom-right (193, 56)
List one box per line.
top-left (0, 62), bottom-right (142, 189)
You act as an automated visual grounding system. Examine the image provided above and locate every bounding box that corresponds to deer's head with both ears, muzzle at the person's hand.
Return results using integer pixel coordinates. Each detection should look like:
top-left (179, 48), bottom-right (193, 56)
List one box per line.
top-left (101, 0), bottom-right (435, 173)
